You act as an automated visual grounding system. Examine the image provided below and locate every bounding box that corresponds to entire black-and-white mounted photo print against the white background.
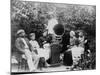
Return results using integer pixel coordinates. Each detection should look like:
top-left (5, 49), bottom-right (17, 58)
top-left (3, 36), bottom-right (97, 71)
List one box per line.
top-left (10, 0), bottom-right (96, 74)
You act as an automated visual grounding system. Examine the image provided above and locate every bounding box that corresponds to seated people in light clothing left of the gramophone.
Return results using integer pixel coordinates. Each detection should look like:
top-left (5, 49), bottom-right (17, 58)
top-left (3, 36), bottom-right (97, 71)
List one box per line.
top-left (15, 29), bottom-right (50, 71)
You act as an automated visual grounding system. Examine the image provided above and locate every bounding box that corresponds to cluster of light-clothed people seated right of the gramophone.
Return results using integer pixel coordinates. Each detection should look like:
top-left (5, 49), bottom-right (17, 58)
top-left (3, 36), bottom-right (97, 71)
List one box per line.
top-left (66, 31), bottom-right (87, 65)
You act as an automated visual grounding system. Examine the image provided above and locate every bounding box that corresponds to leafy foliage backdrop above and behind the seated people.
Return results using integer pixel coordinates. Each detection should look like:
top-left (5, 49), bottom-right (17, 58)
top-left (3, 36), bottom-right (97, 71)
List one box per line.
top-left (11, 0), bottom-right (96, 69)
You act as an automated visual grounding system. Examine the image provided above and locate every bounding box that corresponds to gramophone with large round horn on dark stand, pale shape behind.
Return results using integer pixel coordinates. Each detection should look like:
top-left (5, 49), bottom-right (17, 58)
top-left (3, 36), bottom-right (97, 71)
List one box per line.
top-left (48, 19), bottom-right (65, 65)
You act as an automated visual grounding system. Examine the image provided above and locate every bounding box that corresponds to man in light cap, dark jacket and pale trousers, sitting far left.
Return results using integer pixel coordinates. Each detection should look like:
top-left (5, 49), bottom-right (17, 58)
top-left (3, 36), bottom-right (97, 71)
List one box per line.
top-left (15, 29), bottom-right (34, 71)
